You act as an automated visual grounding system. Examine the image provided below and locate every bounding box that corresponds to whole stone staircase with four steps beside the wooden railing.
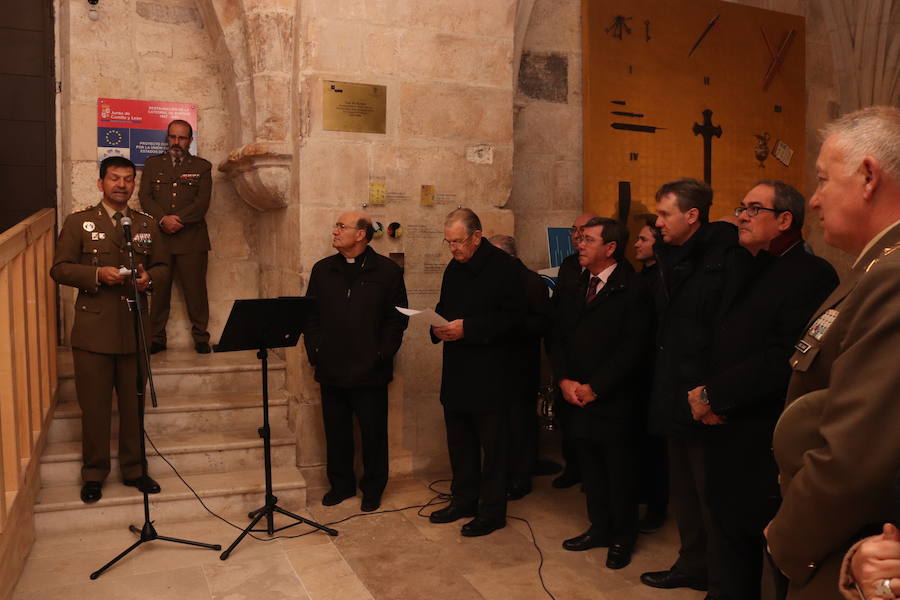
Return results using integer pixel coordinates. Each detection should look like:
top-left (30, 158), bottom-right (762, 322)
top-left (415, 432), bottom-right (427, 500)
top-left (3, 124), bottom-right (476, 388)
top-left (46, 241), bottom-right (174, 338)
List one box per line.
top-left (34, 348), bottom-right (306, 535)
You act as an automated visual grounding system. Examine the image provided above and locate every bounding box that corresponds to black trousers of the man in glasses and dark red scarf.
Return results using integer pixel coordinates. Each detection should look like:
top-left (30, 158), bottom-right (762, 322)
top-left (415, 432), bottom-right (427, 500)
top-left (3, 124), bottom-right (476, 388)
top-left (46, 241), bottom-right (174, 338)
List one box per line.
top-left (704, 423), bottom-right (779, 600)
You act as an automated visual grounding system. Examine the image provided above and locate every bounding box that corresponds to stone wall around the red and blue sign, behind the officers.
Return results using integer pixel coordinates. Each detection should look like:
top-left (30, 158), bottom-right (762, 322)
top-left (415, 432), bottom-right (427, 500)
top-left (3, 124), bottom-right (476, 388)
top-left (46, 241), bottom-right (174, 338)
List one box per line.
top-left (56, 0), bottom-right (259, 348)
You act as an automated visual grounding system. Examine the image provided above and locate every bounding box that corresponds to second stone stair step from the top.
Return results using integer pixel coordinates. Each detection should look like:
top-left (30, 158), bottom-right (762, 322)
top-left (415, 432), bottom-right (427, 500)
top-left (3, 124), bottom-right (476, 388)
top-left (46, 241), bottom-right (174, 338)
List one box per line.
top-left (47, 391), bottom-right (288, 443)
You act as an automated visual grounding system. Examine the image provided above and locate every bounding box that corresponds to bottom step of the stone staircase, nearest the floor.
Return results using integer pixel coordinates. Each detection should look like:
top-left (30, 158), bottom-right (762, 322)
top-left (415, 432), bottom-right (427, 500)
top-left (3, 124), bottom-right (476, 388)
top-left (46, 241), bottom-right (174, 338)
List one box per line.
top-left (34, 466), bottom-right (306, 535)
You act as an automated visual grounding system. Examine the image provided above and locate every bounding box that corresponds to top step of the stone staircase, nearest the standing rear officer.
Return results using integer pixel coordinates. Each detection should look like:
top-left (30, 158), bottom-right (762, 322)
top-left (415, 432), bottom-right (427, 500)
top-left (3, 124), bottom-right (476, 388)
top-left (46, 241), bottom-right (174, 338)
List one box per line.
top-left (58, 348), bottom-right (285, 404)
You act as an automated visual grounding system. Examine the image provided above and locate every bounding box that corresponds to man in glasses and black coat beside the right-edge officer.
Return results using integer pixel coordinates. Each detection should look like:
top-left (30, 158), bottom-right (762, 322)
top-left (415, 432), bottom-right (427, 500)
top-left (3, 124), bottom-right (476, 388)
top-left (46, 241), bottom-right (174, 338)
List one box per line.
top-left (688, 181), bottom-right (838, 600)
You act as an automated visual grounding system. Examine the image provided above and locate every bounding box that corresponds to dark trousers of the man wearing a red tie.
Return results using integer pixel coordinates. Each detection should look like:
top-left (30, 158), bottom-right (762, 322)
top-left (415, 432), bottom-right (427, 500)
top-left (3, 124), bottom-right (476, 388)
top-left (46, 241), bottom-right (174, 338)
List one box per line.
top-left (578, 436), bottom-right (638, 546)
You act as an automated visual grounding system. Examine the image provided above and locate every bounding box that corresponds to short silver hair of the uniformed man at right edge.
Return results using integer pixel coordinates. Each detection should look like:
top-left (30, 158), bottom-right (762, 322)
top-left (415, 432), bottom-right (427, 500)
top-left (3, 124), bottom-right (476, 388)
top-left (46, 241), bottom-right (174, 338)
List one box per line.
top-left (822, 106), bottom-right (900, 183)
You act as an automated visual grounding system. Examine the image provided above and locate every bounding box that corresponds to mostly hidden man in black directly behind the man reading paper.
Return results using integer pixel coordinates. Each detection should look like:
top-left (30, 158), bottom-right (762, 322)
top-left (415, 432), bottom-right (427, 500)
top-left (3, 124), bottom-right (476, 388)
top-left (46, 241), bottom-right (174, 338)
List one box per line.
top-left (490, 235), bottom-right (551, 500)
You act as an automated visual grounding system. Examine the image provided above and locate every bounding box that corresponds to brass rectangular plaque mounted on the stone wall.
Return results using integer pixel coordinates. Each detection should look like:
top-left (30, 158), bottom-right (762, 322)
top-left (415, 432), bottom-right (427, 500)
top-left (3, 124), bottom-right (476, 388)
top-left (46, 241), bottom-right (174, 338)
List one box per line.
top-left (322, 79), bottom-right (387, 133)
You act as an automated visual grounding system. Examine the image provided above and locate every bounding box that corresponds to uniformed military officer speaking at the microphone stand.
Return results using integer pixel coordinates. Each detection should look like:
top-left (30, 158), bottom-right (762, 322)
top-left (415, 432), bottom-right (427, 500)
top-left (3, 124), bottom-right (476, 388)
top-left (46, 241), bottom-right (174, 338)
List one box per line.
top-left (50, 156), bottom-right (168, 502)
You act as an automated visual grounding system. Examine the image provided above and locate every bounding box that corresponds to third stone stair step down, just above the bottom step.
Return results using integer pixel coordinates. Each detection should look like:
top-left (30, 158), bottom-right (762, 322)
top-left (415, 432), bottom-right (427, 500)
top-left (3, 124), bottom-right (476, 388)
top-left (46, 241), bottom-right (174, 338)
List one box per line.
top-left (41, 426), bottom-right (296, 487)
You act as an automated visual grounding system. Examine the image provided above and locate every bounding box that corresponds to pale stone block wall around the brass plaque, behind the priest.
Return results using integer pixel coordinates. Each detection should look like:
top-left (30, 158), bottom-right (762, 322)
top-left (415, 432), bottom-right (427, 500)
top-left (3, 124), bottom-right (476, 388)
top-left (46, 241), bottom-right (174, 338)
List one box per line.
top-left (278, 0), bottom-right (516, 486)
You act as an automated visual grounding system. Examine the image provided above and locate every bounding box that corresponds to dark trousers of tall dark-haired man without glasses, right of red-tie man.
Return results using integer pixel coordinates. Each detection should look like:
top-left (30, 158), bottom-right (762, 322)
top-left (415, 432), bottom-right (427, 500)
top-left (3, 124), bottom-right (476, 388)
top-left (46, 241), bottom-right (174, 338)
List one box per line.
top-left (668, 437), bottom-right (719, 596)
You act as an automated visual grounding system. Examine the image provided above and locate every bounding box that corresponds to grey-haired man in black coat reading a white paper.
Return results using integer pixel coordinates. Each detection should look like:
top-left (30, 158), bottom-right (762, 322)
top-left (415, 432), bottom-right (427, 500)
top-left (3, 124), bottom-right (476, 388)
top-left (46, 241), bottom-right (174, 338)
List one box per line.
top-left (429, 208), bottom-right (527, 537)
